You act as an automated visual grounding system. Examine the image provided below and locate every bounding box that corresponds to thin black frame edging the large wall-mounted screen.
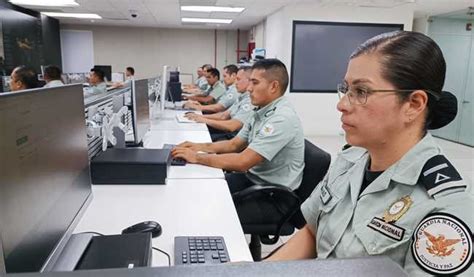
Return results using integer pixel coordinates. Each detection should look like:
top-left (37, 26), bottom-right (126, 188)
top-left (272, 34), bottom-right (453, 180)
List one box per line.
top-left (289, 20), bottom-right (405, 93)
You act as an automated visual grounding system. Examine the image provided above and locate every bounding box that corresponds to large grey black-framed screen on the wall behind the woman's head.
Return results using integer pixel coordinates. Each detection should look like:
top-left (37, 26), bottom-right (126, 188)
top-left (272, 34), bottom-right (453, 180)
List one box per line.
top-left (290, 21), bottom-right (403, 92)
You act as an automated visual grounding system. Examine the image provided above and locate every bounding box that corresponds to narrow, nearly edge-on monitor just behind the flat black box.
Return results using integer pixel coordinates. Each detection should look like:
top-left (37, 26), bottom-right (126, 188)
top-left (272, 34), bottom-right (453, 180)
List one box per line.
top-left (132, 79), bottom-right (150, 145)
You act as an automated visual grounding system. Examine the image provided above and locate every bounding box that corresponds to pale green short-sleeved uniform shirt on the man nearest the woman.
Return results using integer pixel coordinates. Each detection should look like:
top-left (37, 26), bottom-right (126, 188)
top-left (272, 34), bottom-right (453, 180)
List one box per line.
top-left (237, 97), bottom-right (304, 189)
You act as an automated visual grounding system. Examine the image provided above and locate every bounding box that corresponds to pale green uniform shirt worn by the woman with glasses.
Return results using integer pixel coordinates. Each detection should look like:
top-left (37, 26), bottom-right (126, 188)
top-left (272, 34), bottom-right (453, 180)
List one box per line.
top-left (301, 134), bottom-right (474, 276)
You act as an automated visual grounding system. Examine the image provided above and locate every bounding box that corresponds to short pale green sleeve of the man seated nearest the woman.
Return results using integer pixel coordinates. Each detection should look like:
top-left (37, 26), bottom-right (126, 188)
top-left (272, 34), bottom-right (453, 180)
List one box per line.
top-left (248, 115), bottom-right (296, 161)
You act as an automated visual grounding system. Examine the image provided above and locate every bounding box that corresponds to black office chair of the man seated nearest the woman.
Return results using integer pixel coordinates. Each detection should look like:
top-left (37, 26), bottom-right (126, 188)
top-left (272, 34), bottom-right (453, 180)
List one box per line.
top-left (232, 140), bottom-right (331, 261)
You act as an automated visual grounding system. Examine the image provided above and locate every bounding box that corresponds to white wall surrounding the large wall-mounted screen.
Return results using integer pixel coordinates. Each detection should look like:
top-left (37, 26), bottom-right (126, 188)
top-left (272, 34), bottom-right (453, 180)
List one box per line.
top-left (264, 4), bottom-right (413, 136)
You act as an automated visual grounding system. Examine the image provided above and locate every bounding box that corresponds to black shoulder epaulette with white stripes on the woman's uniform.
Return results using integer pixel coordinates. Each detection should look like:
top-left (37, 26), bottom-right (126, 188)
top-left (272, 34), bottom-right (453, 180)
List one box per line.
top-left (418, 155), bottom-right (467, 197)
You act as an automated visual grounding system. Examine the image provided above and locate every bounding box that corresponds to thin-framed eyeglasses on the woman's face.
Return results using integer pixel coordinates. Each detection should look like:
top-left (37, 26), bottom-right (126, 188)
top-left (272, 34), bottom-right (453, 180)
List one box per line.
top-left (337, 84), bottom-right (440, 105)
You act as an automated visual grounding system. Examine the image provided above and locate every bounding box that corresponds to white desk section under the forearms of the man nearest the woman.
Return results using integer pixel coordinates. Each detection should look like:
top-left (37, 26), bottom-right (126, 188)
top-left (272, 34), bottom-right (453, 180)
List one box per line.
top-left (143, 131), bottom-right (224, 179)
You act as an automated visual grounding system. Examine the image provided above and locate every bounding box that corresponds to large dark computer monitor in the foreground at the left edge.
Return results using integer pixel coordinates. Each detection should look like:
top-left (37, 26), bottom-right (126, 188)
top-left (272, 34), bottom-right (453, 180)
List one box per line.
top-left (0, 85), bottom-right (92, 275)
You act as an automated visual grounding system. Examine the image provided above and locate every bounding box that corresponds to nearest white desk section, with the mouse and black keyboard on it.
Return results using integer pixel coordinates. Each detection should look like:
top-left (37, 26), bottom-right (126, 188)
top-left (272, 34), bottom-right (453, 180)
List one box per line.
top-left (75, 179), bottom-right (252, 266)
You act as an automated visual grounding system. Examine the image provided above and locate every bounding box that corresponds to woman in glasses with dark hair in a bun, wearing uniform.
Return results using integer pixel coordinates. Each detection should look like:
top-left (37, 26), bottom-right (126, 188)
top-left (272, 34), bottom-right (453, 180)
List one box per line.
top-left (267, 31), bottom-right (474, 276)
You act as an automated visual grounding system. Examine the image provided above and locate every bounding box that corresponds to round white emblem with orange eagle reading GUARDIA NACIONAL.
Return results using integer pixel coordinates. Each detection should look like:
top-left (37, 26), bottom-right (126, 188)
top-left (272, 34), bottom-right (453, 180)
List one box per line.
top-left (412, 213), bottom-right (472, 275)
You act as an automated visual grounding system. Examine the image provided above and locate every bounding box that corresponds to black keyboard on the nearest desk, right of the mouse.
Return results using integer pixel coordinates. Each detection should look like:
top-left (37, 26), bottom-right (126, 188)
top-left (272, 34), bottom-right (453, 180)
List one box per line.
top-left (174, 234), bottom-right (230, 265)
